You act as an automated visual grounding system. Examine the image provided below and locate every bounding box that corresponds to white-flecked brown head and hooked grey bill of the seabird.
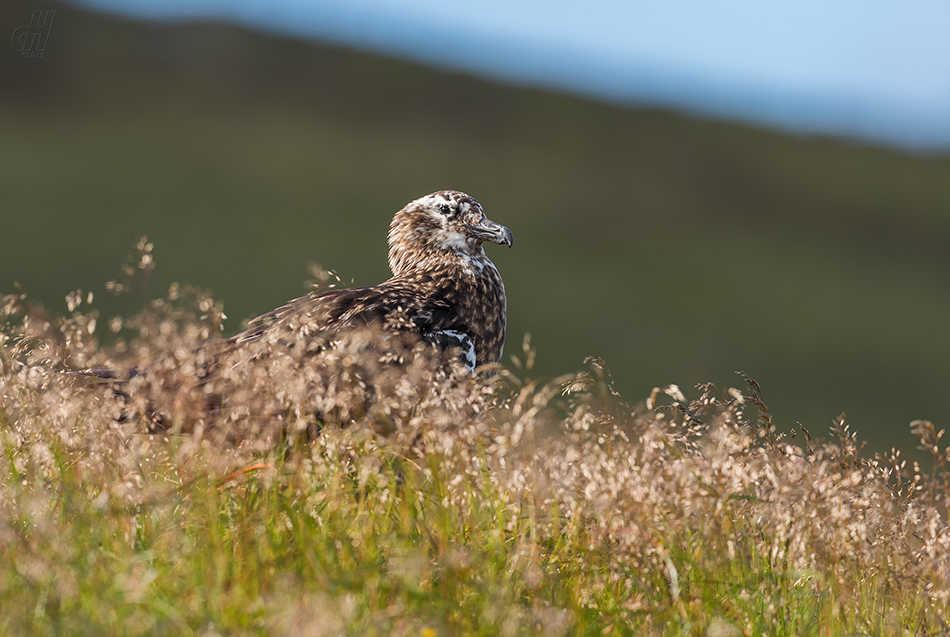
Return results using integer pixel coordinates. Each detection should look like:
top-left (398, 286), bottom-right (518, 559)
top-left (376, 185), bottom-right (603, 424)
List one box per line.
top-left (389, 190), bottom-right (512, 275)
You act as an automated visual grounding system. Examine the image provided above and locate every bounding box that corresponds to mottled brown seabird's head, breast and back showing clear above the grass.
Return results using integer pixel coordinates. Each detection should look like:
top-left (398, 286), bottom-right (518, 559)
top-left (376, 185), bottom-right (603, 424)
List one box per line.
top-left (229, 190), bottom-right (512, 369)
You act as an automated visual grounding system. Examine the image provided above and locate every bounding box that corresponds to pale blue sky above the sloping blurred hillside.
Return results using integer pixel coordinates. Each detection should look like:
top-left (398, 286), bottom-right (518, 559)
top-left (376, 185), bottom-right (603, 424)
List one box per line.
top-left (74, 0), bottom-right (950, 152)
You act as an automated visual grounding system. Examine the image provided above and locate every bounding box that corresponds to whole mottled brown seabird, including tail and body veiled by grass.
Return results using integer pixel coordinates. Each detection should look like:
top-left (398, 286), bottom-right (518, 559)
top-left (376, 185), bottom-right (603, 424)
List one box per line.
top-left (72, 190), bottom-right (513, 431)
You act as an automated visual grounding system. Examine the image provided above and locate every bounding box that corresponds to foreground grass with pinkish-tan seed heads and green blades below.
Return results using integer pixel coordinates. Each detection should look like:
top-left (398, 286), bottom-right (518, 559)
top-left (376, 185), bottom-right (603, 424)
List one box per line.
top-left (0, 244), bottom-right (950, 636)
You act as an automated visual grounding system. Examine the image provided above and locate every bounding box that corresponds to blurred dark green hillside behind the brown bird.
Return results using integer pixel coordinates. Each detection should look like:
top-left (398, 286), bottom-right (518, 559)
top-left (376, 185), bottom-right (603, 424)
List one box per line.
top-left (0, 0), bottom-right (950, 449)
